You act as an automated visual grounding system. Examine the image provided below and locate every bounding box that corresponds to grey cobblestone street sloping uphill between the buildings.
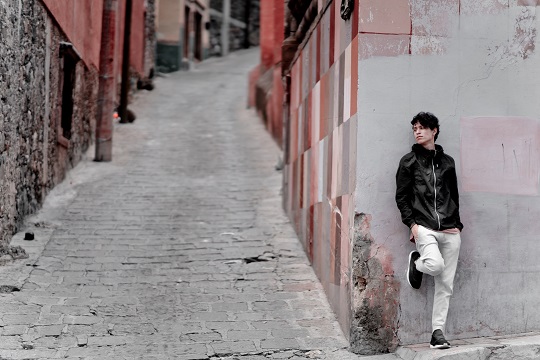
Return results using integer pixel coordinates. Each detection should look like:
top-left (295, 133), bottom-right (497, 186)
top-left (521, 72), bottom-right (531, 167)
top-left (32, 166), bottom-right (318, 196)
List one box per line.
top-left (0, 49), bottom-right (357, 359)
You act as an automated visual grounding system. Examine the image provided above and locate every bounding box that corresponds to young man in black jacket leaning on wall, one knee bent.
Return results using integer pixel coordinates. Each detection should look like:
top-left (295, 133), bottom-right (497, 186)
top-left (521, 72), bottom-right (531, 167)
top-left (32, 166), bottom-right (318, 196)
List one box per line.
top-left (396, 112), bottom-right (463, 349)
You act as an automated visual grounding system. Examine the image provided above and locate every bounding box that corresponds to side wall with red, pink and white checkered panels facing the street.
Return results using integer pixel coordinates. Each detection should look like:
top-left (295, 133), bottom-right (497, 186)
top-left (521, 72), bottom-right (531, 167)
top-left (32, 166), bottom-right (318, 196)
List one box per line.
top-left (284, 1), bottom-right (359, 344)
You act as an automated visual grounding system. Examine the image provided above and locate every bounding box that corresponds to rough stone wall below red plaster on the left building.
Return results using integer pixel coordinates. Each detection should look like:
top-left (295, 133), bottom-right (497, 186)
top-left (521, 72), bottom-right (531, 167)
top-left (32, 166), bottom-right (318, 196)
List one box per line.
top-left (0, 0), bottom-right (98, 243)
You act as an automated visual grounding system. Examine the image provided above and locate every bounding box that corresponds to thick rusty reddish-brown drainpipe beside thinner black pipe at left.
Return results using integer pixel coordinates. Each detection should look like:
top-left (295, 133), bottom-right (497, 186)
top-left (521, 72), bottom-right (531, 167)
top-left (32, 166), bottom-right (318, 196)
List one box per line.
top-left (94, 0), bottom-right (118, 161)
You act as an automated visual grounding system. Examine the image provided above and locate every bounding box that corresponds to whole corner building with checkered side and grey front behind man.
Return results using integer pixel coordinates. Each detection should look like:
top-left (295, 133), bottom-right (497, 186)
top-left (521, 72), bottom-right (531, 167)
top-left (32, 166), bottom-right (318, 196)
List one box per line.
top-left (252, 0), bottom-right (540, 354)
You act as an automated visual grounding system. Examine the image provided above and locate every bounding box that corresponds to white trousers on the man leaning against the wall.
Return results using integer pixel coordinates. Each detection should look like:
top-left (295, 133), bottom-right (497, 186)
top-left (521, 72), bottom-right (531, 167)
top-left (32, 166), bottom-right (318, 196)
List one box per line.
top-left (415, 226), bottom-right (461, 333)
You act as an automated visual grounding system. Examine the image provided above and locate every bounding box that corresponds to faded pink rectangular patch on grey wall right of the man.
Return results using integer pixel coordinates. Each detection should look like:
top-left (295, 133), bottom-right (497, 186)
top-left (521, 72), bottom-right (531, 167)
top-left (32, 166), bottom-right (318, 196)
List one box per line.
top-left (460, 116), bottom-right (540, 195)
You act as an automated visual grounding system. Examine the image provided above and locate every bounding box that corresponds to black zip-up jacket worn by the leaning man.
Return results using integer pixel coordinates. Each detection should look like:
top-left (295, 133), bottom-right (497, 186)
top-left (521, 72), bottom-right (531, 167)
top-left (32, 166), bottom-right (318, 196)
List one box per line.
top-left (396, 144), bottom-right (463, 231)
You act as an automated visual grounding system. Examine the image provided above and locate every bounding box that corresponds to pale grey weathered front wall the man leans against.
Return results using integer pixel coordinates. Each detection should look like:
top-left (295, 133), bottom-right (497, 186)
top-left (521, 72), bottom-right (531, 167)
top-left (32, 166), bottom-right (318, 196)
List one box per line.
top-left (353, 0), bottom-right (540, 344)
